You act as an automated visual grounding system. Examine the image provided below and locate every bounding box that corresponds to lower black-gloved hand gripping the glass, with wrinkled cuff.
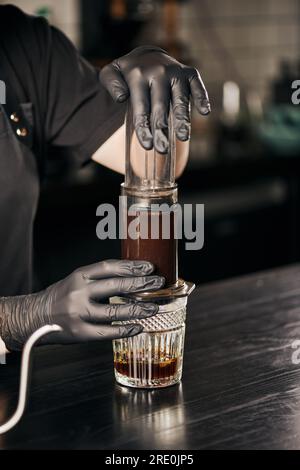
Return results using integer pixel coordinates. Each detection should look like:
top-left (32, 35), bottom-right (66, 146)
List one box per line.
top-left (0, 260), bottom-right (164, 350)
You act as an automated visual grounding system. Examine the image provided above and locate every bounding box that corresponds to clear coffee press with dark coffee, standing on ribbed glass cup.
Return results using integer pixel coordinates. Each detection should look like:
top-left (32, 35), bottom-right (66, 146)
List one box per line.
top-left (111, 106), bottom-right (195, 388)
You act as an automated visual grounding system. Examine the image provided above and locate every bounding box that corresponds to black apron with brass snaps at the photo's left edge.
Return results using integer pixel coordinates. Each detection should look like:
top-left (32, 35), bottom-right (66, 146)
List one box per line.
top-left (0, 95), bottom-right (39, 296)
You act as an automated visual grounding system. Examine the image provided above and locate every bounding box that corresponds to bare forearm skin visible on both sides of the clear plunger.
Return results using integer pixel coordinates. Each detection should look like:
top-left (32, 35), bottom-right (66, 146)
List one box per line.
top-left (92, 125), bottom-right (189, 178)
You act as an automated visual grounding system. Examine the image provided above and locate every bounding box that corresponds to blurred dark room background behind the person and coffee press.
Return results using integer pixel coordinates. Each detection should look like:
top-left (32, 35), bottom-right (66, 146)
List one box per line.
top-left (2, 0), bottom-right (300, 285)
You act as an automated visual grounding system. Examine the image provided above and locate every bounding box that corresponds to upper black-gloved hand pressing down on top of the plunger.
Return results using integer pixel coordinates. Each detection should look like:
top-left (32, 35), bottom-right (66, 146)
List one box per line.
top-left (100, 46), bottom-right (210, 153)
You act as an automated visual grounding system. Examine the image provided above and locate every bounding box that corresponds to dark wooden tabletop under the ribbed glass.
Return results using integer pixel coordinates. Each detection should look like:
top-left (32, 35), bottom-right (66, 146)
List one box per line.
top-left (0, 266), bottom-right (300, 450)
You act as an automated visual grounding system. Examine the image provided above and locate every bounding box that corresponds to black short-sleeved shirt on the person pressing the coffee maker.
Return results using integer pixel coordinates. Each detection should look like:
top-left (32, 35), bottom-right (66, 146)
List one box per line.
top-left (0, 5), bottom-right (124, 296)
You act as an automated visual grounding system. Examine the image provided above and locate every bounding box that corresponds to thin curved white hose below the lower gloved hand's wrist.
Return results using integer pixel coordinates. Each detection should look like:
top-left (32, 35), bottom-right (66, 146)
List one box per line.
top-left (0, 325), bottom-right (62, 435)
